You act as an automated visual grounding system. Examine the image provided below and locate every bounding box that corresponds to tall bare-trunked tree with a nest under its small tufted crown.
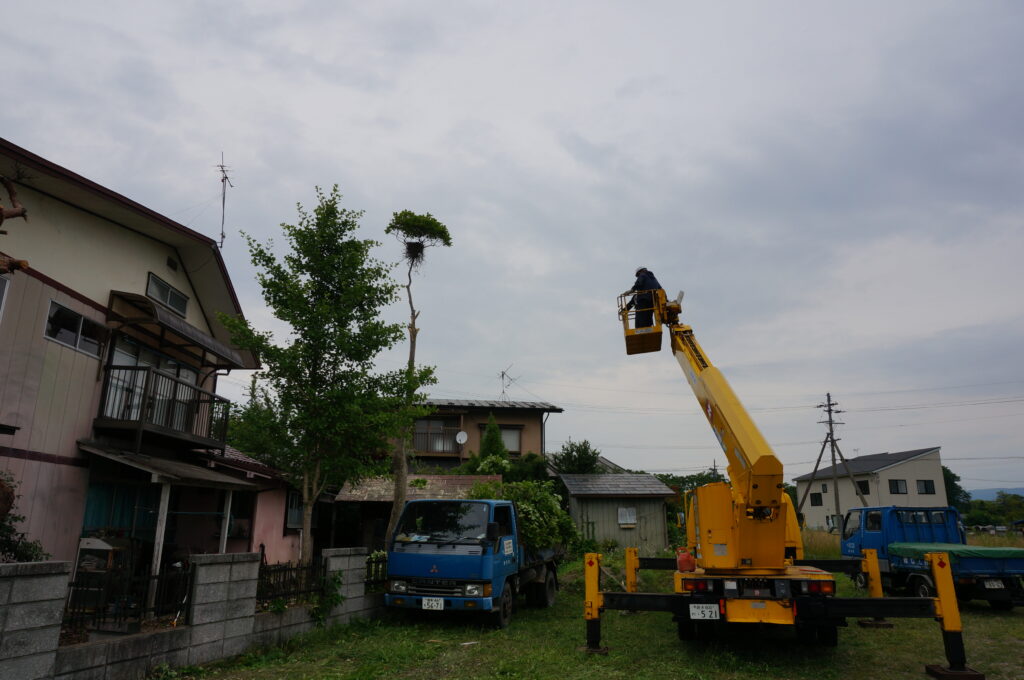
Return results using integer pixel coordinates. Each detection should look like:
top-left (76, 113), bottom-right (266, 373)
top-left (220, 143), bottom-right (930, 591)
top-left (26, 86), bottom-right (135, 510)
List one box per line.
top-left (384, 210), bottom-right (452, 536)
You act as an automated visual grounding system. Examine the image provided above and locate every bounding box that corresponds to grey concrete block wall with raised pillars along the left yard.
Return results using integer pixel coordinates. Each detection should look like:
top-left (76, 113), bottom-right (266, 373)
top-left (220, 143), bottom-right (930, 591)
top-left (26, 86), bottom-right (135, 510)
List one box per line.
top-left (0, 548), bottom-right (383, 680)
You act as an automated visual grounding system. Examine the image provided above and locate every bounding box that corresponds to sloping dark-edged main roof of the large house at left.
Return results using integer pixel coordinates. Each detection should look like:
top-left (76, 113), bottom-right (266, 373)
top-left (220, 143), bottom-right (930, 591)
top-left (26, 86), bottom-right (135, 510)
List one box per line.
top-left (0, 137), bottom-right (259, 369)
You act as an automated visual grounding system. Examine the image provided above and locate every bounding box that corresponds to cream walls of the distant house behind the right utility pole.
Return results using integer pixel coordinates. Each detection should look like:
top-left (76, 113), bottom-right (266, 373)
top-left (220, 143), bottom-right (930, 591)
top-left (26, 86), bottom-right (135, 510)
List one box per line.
top-left (797, 451), bottom-right (948, 528)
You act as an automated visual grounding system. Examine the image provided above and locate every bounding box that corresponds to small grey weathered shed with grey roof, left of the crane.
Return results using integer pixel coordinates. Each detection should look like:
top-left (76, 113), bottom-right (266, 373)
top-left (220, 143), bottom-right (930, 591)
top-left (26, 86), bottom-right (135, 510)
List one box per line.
top-left (560, 474), bottom-right (676, 555)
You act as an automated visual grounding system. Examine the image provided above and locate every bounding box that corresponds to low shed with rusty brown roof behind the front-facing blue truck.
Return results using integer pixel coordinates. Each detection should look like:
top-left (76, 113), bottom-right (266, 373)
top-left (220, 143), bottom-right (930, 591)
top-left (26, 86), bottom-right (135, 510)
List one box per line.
top-left (335, 473), bottom-right (502, 550)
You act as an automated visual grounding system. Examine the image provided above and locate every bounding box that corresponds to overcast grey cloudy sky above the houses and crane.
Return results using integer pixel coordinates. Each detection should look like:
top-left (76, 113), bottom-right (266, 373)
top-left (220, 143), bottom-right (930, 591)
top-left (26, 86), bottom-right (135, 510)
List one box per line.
top-left (0, 0), bottom-right (1024, 488)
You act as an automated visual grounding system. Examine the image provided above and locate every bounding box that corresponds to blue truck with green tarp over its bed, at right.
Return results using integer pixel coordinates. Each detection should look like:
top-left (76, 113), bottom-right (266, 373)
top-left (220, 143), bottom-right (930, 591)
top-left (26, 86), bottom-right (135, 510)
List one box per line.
top-left (842, 506), bottom-right (1024, 610)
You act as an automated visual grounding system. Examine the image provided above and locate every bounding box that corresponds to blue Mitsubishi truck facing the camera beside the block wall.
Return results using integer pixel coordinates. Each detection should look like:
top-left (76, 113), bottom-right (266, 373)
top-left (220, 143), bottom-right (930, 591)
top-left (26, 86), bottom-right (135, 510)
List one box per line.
top-left (384, 499), bottom-right (560, 628)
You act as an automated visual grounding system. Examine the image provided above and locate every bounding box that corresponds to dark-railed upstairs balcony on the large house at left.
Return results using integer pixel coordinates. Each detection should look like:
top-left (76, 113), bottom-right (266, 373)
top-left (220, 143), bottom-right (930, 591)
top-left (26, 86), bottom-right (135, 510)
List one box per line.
top-left (93, 366), bottom-right (231, 452)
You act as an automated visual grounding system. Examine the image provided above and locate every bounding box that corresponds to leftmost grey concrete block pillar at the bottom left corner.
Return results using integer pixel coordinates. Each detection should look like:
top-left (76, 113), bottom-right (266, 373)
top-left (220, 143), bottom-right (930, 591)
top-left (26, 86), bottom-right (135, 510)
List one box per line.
top-left (0, 562), bottom-right (71, 680)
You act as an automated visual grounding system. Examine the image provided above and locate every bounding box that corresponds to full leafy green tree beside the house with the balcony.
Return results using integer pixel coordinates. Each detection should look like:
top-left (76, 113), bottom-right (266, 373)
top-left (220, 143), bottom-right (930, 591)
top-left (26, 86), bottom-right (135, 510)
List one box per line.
top-left (221, 186), bottom-right (430, 563)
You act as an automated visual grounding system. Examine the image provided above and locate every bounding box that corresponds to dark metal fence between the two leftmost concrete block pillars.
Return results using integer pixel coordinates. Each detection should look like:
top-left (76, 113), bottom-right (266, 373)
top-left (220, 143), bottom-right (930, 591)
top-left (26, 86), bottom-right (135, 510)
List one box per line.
top-left (63, 569), bottom-right (193, 633)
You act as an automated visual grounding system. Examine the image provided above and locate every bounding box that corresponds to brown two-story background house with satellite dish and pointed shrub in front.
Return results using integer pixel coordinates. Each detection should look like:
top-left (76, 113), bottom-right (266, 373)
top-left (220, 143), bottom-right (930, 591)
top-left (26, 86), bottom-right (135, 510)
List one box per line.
top-left (412, 399), bottom-right (562, 469)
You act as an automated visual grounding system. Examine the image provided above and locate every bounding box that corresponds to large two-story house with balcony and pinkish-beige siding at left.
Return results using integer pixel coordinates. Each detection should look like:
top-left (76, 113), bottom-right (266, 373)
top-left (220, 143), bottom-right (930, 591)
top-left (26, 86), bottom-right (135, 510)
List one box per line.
top-left (0, 139), bottom-right (284, 572)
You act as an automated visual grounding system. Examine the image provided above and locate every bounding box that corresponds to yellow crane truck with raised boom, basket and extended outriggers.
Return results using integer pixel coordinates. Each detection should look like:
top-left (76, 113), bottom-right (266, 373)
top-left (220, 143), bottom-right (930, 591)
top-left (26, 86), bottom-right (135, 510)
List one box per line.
top-left (584, 290), bottom-right (983, 678)
